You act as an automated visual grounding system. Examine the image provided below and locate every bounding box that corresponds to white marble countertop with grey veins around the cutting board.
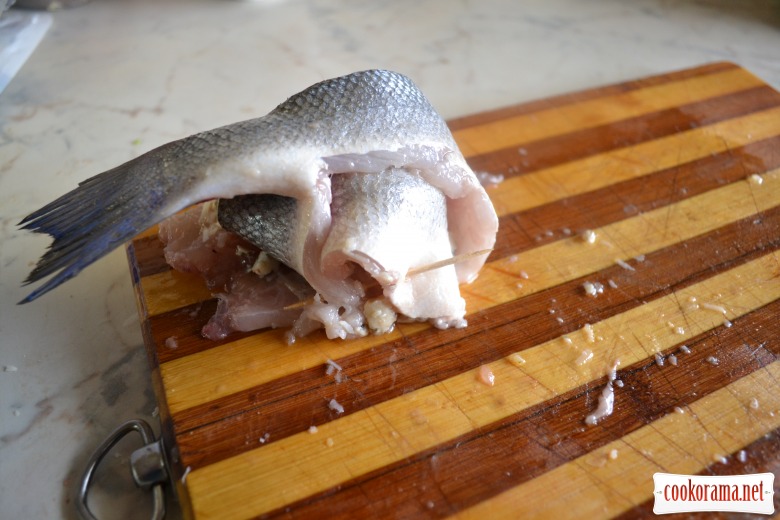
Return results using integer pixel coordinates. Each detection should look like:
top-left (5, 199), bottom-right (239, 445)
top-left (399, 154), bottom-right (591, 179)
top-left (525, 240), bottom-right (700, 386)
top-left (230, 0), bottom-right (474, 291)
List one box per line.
top-left (0, 0), bottom-right (780, 519)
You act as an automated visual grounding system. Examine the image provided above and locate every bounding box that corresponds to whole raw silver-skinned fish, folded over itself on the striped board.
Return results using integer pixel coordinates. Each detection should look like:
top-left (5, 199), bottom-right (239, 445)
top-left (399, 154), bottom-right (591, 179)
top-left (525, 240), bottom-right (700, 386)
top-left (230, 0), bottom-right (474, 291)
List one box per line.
top-left (20, 70), bottom-right (498, 338)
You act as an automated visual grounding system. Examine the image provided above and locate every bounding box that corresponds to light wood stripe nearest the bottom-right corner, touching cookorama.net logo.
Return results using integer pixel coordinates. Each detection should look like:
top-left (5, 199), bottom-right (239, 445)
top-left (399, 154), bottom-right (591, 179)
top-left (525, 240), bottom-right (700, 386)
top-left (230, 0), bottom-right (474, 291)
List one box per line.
top-left (453, 361), bottom-right (780, 519)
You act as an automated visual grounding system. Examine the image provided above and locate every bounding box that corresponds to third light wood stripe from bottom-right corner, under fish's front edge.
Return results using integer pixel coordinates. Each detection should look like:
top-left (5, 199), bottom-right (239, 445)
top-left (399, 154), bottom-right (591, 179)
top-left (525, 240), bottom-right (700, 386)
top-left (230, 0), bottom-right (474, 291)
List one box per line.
top-left (160, 169), bottom-right (780, 414)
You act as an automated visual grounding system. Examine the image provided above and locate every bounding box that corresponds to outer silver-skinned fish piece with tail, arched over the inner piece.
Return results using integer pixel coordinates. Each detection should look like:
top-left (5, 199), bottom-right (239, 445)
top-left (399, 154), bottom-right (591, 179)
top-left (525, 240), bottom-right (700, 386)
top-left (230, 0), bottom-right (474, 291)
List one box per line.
top-left (20, 70), bottom-right (498, 314)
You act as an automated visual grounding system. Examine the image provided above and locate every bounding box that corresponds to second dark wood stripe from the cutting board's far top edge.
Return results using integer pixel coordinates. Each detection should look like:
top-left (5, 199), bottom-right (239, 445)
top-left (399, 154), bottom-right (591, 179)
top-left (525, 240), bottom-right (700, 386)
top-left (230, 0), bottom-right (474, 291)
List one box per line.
top-left (467, 86), bottom-right (780, 178)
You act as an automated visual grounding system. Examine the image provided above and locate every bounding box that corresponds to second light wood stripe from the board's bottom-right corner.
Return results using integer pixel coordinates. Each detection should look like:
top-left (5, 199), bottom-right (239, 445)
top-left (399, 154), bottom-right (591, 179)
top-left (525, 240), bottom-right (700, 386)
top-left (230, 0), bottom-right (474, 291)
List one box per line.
top-left (181, 253), bottom-right (780, 518)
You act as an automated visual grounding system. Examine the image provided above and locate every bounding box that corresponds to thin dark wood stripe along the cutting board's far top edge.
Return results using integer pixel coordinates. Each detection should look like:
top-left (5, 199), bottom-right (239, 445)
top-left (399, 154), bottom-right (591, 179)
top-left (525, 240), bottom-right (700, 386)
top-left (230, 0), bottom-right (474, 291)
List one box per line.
top-left (448, 62), bottom-right (737, 130)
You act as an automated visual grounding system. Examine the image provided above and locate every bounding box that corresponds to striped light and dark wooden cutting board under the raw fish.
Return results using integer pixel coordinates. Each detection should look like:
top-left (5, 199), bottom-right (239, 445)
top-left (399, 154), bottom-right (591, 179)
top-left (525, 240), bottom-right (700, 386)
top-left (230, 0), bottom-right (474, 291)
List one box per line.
top-left (128, 63), bottom-right (780, 519)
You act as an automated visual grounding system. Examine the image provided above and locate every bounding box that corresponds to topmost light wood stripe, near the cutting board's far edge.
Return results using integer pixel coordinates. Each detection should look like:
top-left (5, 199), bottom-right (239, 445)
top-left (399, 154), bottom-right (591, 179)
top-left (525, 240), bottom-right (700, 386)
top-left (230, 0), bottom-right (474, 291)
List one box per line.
top-left (454, 65), bottom-right (764, 156)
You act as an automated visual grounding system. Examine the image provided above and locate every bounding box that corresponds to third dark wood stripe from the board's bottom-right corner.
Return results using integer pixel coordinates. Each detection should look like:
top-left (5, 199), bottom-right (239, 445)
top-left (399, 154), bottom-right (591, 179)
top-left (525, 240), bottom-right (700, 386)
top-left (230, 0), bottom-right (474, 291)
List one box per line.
top-left (173, 206), bottom-right (780, 469)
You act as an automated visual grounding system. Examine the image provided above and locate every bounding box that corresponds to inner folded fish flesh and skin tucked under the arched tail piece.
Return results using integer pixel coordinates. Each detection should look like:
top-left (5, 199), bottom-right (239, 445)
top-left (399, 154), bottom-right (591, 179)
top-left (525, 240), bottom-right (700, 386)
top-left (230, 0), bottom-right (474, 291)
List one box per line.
top-left (160, 167), bottom-right (465, 339)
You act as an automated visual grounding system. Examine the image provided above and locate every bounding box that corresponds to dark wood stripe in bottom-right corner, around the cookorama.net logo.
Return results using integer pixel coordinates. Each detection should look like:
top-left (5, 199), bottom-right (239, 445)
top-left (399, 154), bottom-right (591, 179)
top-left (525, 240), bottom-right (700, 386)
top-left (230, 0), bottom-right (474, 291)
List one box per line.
top-left (615, 429), bottom-right (780, 520)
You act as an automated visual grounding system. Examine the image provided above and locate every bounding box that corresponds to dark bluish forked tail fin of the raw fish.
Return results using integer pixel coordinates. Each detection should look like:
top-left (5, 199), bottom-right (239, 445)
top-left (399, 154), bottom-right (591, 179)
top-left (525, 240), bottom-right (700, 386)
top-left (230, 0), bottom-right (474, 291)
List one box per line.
top-left (19, 145), bottom-right (183, 304)
